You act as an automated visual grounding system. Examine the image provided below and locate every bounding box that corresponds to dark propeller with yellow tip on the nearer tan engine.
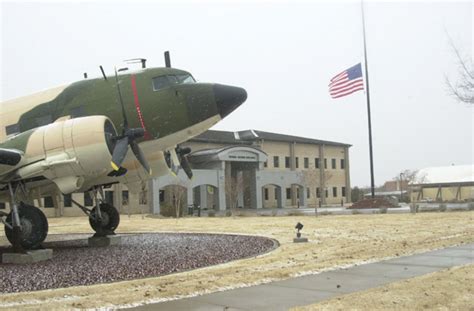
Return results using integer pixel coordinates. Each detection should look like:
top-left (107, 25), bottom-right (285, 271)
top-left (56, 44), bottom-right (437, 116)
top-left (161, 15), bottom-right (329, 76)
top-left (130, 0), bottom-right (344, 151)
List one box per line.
top-left (110, 69), bottom-right (151, 175)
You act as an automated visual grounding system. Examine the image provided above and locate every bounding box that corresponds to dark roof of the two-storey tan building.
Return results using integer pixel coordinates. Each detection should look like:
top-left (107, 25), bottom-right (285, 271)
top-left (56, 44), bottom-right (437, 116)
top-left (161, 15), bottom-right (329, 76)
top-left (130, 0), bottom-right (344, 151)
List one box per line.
top-left (190, 130), bottom-right (351, 147)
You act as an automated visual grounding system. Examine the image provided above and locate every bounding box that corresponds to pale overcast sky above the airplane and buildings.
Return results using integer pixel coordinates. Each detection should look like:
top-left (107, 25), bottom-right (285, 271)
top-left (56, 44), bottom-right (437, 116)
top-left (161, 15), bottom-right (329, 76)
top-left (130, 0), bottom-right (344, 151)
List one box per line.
top-left (0, 1), bottom-right (474, 186)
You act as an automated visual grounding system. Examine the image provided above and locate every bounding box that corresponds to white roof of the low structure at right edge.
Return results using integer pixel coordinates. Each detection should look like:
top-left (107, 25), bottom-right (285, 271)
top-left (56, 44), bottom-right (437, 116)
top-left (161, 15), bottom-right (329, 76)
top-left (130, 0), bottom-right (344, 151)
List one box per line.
top-left (414, 164), bottom-right (474, 184)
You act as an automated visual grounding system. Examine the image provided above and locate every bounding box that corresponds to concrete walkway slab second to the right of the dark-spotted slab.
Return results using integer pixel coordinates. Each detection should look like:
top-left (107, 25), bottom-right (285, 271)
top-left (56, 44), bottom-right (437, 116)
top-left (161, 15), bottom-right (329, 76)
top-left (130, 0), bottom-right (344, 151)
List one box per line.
top-left (384, 255), bottom-right (473, 268)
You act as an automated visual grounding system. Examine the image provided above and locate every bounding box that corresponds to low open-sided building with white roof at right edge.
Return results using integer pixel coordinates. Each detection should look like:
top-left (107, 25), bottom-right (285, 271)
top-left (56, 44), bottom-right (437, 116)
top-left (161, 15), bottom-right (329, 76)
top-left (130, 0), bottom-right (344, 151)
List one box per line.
top-left (409, 165), bottom-right (474, 202)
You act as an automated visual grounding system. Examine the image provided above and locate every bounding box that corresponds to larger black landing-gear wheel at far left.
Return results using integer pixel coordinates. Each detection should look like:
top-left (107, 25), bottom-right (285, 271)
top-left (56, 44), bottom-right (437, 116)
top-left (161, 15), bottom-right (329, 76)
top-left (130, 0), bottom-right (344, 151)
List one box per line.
top-left (5, 202), bottom-right (48, 249)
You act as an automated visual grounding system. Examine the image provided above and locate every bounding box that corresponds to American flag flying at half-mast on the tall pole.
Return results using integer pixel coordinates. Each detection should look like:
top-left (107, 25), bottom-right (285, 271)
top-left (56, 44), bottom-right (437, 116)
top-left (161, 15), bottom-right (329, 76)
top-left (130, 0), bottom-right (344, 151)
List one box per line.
top-left (329, 63), bottom-right (364, 98)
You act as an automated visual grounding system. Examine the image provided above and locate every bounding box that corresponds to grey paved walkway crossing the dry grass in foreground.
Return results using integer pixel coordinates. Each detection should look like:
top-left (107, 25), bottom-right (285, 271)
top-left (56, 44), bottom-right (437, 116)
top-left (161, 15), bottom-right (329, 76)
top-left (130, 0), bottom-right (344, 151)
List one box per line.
top-left (133, 243), bottom-right (474, 311)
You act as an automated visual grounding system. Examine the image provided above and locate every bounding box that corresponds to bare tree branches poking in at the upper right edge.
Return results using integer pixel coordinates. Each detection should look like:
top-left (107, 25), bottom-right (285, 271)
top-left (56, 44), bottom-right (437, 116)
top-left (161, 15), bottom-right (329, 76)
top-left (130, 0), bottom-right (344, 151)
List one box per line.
top-left (445, 31), bottom-right (474, 105)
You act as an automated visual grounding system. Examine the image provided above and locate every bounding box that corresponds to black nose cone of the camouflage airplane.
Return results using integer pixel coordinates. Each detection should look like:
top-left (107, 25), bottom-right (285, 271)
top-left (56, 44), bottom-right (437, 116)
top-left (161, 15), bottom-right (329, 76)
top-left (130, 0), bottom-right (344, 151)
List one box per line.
top-left (214, 84), bottom-right (247, 118)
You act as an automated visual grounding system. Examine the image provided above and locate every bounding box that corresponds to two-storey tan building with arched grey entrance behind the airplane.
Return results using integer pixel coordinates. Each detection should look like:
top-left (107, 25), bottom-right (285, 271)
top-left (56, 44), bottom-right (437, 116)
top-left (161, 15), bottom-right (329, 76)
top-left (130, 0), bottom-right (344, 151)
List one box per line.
top-left (150, 130), bottom-right (350, 214)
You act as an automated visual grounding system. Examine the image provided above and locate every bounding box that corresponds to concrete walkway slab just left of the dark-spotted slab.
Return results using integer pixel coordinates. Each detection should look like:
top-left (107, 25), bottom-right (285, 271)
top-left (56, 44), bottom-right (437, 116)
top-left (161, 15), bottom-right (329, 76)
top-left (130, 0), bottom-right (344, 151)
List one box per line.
top-left (194, 283), bottom-right (337, 310)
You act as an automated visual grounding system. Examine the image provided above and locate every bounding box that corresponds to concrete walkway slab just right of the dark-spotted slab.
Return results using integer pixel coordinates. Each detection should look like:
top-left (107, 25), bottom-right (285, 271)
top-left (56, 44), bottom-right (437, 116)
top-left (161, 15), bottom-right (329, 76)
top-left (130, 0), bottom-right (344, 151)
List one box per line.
top-left (341, 262), bottom-right (439, 282)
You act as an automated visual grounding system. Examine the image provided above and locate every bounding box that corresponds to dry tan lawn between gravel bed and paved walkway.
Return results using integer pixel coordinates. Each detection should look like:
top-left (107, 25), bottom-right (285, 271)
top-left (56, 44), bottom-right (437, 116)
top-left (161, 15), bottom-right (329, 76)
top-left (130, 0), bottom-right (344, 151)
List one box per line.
top-left (0, 212), bottom-right (474, 309)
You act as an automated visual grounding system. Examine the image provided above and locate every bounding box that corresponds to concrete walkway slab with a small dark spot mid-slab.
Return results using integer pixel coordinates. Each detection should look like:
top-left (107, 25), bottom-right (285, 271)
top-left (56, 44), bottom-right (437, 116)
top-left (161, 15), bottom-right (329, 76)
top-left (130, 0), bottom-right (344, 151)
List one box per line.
top-left (272, 271), bottom-right (395, 295)
